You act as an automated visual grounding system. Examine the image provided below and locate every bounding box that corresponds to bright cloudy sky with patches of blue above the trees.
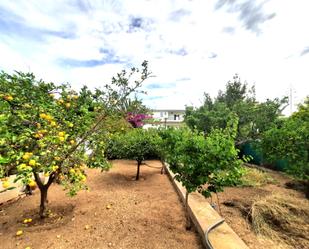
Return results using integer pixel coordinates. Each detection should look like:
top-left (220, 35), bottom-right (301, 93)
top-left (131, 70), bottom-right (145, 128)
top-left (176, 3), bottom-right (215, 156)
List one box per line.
top-left (0, 0), bottom-right (309, 110)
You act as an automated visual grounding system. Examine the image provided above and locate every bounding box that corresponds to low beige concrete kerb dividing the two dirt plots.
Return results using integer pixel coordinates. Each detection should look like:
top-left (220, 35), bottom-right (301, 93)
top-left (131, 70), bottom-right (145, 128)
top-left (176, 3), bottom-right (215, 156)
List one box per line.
top-left (164, 164), bottom-right (249, 249)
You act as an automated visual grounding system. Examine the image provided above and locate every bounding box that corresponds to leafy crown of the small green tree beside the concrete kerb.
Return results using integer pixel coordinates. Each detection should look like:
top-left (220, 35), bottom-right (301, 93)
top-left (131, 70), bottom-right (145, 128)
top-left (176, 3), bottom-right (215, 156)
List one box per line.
top-left (159, 115), bottom-right (242, 228)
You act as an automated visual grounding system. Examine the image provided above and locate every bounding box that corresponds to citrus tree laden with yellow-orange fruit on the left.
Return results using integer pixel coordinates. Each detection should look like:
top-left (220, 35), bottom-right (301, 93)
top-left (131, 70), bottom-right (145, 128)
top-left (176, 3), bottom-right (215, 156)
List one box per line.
top-left (0, 62), bottom-right (150, 218)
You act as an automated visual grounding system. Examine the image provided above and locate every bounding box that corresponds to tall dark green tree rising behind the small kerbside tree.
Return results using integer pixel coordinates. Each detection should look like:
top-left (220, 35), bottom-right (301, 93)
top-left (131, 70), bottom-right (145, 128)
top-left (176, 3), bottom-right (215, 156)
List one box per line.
top-left (185, 75), bottom-right (287, 144)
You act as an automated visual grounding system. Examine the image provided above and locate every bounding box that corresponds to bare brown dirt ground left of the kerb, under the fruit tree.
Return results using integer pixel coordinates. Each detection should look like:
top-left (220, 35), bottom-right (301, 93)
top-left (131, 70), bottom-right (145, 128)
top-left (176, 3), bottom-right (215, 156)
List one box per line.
top-left (0, 161), bottom-right (202, 249)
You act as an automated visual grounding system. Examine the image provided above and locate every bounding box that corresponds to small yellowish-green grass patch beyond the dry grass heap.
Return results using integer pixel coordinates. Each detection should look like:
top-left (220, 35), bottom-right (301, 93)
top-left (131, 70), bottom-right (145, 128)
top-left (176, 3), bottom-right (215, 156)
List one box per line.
top-left (241, 168), bottom-right (275, 187)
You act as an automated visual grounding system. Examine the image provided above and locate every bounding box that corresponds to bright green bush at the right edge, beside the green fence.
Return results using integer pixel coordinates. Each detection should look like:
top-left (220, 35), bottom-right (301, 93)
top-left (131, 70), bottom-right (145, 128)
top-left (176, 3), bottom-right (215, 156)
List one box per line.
top-left (262, 98), bottom-right (309, 181)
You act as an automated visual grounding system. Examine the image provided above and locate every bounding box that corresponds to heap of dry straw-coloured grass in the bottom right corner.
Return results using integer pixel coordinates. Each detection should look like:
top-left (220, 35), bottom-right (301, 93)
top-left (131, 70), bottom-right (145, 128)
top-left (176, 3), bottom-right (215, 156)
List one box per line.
top-left (251, 194), bottom-right (309, 249)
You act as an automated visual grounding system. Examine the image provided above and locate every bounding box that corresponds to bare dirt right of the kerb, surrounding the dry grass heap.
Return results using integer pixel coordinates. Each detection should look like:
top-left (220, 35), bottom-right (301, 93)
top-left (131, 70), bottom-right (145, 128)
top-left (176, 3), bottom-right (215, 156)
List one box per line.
top-left (208, 167), bottom-right (309, 249)
